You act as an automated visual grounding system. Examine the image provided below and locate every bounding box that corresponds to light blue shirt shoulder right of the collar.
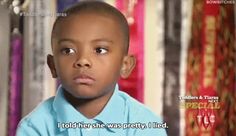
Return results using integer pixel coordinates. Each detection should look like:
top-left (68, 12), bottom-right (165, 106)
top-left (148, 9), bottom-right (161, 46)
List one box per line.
top-left (119, 92), bottom-right (168, 136)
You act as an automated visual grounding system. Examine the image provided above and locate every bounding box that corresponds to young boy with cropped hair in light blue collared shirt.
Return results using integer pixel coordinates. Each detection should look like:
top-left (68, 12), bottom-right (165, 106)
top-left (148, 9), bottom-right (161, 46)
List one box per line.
top-left (17, 1), bottom-right (166, 136)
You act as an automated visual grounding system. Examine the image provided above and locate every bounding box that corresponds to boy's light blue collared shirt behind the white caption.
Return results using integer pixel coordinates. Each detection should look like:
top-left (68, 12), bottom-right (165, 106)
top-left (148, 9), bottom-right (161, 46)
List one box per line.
top-left (16, 86), bottom-right (166, 136)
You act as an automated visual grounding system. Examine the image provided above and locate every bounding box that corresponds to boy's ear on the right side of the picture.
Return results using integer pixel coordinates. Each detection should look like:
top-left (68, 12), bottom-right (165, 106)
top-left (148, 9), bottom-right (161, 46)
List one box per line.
top-left (120, 55), bottom-right (136, 78)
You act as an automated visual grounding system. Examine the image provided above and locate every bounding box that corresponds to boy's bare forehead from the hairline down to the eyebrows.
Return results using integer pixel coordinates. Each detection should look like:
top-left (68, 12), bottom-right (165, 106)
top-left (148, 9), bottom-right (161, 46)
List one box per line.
top-left (52, 14), bottom-right (124, 46)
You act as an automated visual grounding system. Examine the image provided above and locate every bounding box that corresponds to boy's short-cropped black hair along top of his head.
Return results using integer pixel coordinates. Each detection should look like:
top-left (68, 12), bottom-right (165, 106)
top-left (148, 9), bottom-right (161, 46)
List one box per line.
top-left (51, 0), bottom-right (129, 53)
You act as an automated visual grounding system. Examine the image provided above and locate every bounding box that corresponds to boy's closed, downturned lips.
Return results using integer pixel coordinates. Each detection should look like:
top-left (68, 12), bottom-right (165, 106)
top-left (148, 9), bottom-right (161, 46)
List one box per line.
top-left (73, 74), bottom-right (95, 85)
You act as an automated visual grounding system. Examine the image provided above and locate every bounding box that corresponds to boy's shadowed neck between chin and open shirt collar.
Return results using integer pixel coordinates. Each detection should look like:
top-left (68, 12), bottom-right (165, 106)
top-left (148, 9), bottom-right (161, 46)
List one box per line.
top-left (64, 88), bottom-right (114, 119)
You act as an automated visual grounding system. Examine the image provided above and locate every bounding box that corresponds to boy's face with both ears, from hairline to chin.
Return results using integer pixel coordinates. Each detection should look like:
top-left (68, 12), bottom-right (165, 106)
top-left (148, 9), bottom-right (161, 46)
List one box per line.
top-left (48, 13), bottom-right (135, 99)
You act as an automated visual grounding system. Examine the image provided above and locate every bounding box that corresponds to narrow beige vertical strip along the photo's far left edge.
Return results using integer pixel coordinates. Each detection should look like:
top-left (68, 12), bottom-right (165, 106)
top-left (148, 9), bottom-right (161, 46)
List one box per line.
top-left (0, 5), bottom-right (10, 136)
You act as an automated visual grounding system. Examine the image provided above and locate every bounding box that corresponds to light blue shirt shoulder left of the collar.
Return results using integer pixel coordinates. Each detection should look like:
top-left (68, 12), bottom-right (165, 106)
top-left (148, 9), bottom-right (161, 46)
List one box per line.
top-left (17, 97), bottom-right (54, 136)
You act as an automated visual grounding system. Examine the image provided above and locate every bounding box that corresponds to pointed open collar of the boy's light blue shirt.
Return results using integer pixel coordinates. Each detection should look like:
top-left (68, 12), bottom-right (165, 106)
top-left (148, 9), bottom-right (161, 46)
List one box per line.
top-left (53, 85), bottom-right (125, 132)
